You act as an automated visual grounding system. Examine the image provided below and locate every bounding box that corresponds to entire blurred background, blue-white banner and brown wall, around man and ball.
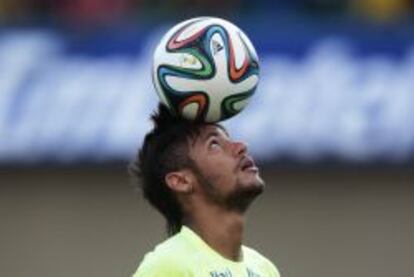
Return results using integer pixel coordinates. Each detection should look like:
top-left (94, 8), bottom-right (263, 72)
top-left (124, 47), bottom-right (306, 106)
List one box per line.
top-left (0, 0), bottom-right (414, 277)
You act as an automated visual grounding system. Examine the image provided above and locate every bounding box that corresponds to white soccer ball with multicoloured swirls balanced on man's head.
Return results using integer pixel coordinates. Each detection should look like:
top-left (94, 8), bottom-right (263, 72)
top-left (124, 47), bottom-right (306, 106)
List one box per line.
top-left (153, 17), bottom-right (259, 123)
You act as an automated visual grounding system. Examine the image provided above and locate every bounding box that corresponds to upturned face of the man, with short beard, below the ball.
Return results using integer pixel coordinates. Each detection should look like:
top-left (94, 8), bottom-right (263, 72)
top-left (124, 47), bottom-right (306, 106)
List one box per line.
top-left (190, 125), bottom-right (264, 211)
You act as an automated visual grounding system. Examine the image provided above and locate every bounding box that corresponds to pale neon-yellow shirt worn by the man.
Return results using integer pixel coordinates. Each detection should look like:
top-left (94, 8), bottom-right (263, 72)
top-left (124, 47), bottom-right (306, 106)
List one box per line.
top-left (133, 226), bottom-right (280, 277)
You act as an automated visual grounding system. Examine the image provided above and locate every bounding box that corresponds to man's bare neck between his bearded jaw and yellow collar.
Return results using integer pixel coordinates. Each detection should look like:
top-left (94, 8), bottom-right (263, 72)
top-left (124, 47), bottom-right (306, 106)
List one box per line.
top-left (186, 203), bottom-right (245, 261)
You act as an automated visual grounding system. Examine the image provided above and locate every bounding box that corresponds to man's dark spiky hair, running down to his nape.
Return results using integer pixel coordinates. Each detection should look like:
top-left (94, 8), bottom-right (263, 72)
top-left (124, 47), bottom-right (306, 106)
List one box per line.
top-left (129, 104), bottom-right (203, 235)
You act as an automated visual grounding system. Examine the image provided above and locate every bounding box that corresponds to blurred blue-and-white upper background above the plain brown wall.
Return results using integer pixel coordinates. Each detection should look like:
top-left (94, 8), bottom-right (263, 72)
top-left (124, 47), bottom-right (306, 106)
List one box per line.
top-left (0, 0), bottom-right (414, 164)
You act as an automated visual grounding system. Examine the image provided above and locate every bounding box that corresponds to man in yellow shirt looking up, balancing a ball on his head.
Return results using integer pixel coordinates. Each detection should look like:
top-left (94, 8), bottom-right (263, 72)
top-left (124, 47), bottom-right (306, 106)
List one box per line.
top-left (131, 105), bottom-right (279, 277)
